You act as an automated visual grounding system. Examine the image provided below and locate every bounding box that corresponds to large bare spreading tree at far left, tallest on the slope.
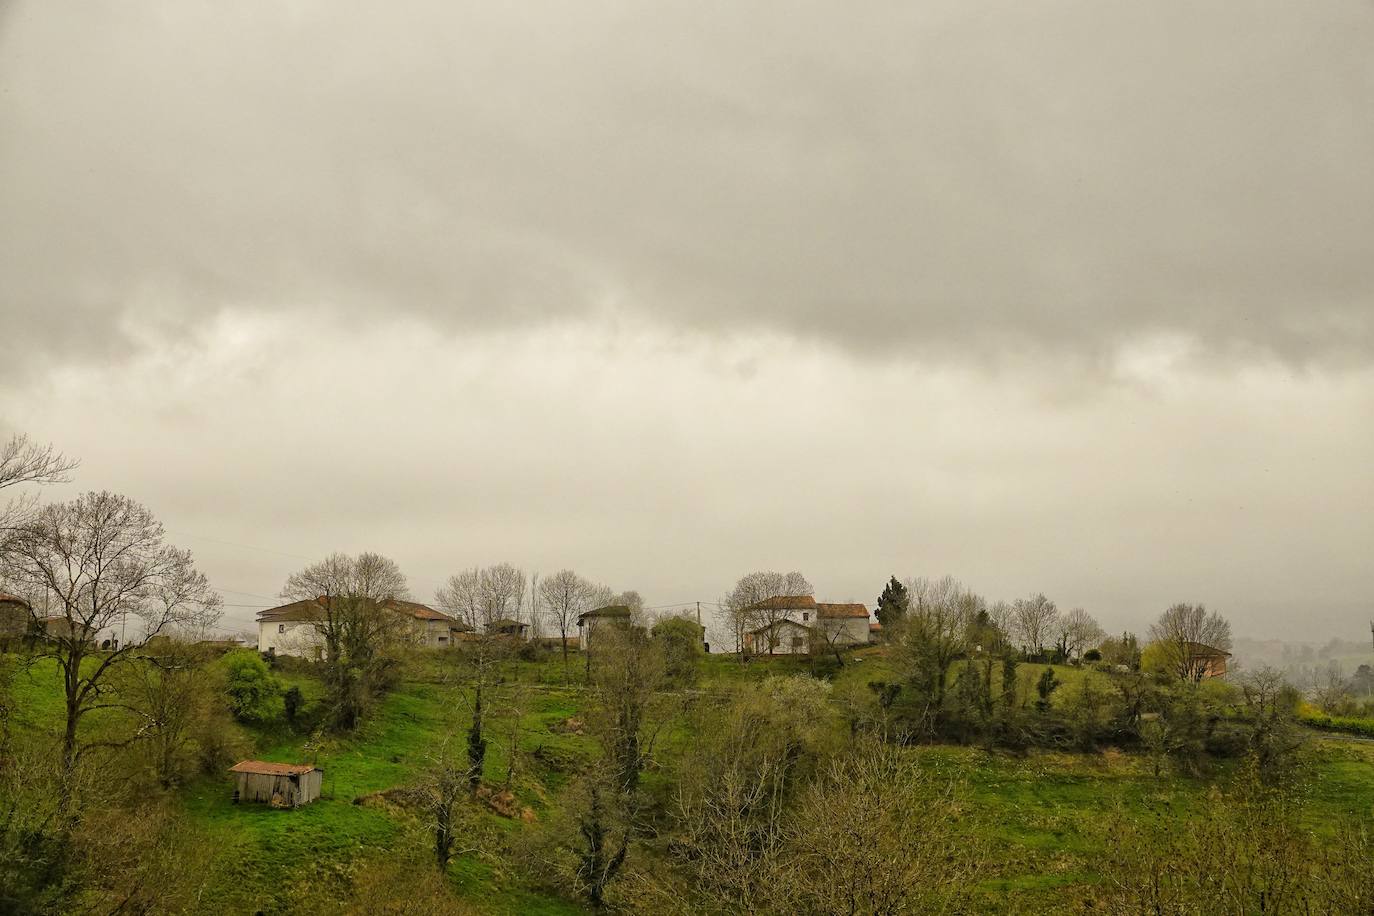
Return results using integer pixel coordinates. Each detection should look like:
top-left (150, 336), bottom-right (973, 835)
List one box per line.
top-left (4, 493), bottom-right (220, 777)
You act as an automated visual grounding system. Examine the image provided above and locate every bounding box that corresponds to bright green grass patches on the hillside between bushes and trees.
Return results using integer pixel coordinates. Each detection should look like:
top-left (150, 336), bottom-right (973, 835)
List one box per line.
top-left (15, 651), bottom-right (1374, 913)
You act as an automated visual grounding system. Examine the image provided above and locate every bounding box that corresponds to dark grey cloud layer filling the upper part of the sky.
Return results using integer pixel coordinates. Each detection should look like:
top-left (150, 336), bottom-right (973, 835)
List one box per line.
top-left (0, 0), bottom-right (1374, 373)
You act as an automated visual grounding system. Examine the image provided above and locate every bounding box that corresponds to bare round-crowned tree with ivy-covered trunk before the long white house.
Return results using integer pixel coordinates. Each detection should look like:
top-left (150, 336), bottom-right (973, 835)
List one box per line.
top-left (282, 553), bottom-right (411, 728)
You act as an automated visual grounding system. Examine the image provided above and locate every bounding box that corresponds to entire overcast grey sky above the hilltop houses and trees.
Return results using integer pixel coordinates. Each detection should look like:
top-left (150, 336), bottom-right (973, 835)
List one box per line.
top-left (0, 0), bottom-right (1374, 640)
